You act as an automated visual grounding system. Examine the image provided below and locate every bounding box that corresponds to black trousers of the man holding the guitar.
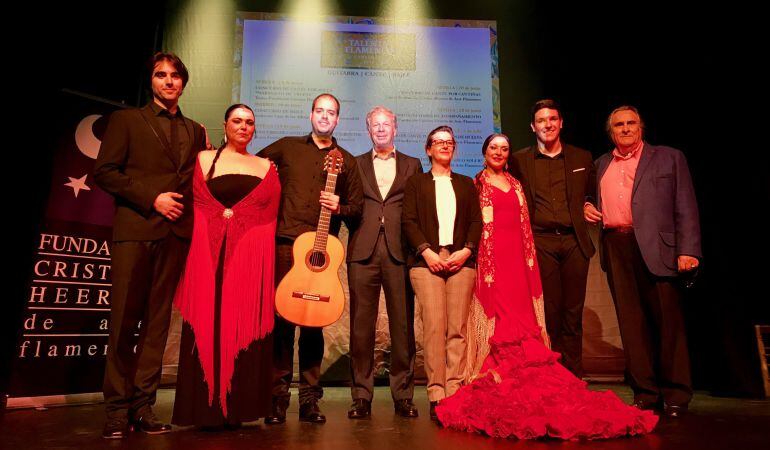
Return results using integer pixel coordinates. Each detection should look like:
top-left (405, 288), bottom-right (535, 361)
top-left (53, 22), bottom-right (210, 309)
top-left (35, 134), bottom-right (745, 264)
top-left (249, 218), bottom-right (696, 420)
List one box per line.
top-left (273, 243), bottom-right (324, 403)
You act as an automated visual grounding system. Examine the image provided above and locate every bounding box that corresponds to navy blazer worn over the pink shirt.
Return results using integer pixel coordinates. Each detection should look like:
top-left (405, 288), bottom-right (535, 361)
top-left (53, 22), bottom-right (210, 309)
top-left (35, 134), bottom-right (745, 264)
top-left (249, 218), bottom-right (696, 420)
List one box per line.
top-left (596, 142), bottom-right (703, 277)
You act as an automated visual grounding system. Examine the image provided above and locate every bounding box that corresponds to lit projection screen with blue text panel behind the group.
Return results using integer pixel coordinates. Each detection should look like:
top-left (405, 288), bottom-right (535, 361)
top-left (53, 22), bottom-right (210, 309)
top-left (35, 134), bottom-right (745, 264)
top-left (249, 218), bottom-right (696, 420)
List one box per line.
top-left (233, 13), bottom-right (500, 176)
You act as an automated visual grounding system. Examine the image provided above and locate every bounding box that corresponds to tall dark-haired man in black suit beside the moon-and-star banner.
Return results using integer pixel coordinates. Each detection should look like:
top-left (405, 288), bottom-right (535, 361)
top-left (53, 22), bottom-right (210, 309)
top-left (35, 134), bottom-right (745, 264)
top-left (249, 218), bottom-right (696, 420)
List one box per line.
top-left (94, 53), bottom-right (206, 439)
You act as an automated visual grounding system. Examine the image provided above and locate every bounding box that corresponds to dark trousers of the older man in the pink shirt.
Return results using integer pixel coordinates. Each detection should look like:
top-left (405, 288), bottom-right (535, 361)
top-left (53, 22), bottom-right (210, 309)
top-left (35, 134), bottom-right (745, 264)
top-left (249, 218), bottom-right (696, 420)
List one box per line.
top-left (602, 231), bottom-right (692, 406)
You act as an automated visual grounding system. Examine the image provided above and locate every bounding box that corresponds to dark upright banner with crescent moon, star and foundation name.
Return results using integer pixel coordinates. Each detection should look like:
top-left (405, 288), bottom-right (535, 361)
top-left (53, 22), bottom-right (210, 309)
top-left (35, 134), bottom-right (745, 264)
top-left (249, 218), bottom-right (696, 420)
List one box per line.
top-left (9, 92), bottom-right (117, 397)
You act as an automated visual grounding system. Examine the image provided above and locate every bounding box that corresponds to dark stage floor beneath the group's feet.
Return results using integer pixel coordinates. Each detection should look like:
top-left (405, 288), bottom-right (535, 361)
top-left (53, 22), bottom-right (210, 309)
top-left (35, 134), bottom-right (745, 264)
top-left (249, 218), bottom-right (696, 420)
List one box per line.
top-left (0, 385), bottom-right (770, 450)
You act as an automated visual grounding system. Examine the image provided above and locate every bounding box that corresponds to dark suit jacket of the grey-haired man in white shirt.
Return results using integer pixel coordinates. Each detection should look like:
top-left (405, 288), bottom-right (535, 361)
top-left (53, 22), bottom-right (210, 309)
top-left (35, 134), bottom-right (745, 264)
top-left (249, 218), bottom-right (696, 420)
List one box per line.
top-left (348, 150), bottom-right (422, 263)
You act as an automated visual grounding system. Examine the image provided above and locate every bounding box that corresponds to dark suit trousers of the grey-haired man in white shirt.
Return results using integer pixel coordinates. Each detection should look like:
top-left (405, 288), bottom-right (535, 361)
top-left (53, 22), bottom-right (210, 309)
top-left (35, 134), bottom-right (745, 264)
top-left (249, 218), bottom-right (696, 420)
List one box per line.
top-left (348, 232), bottom-right (415, 401)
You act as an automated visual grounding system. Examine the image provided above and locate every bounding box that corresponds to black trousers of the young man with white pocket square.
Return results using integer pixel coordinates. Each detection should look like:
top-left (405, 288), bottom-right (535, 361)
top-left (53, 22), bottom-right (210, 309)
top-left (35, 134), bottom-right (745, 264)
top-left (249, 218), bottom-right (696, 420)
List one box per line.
top-left (535, 233), bottom-right (590, 377)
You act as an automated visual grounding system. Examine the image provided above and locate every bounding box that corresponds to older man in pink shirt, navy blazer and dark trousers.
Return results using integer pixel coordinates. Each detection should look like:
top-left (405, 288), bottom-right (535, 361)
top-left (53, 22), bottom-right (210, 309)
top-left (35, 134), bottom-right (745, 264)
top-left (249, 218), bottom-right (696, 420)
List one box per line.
top-left (583, 106), bottom-right (702, 417)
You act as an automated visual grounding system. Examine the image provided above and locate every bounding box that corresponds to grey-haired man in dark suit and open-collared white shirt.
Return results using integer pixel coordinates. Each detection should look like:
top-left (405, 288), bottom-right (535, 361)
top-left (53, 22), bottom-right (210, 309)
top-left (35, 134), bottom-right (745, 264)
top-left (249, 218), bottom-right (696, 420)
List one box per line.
top-left (348, 106), bottom-right (422, 419)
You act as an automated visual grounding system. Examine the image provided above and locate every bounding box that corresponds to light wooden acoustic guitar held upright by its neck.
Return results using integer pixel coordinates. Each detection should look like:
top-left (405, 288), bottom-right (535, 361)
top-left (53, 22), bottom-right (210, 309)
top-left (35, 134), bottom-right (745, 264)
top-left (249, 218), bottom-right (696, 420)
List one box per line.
top-left (275, 149), bottom-right (345, 327)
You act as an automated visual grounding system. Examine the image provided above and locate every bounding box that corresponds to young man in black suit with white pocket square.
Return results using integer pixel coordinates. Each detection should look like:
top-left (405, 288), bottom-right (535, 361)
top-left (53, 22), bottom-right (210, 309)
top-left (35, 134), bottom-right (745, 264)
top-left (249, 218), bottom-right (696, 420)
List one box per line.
top-left (509, 99), bottom-right (595, 377)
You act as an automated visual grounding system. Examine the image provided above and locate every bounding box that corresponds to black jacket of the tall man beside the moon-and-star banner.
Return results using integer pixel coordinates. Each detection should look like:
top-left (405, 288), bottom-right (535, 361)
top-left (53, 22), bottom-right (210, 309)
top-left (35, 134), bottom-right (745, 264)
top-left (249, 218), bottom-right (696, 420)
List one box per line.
top-left (94, 105), bottom-right (206, 241)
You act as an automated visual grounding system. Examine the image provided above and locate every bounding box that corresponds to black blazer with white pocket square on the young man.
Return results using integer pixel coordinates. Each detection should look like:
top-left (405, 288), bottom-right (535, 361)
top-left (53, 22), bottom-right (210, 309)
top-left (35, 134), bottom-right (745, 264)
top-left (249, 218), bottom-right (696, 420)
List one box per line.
top-left (508, 144), bottom-right (596, 258)
